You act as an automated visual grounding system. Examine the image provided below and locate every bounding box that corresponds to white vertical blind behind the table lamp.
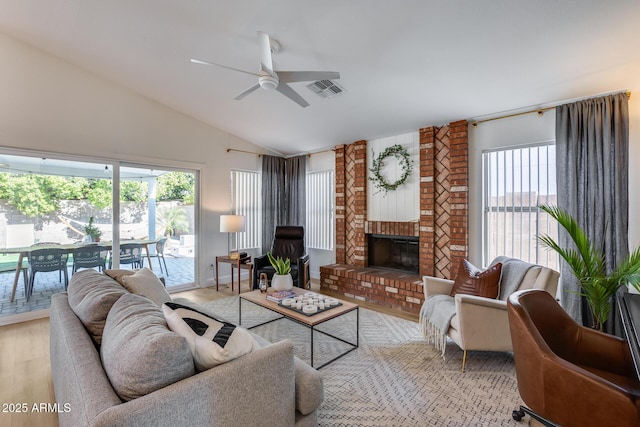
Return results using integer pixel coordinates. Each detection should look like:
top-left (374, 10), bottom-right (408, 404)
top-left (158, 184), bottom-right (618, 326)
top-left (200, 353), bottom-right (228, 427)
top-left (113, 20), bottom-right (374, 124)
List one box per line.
top-left (231, 170), bottom-right (262, 250)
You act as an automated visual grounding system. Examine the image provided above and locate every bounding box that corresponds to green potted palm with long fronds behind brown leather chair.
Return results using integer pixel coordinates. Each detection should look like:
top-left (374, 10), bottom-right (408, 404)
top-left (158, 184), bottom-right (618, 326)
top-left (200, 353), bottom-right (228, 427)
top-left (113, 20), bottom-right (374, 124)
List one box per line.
top-left (538, 205), bottom-right (640, 331)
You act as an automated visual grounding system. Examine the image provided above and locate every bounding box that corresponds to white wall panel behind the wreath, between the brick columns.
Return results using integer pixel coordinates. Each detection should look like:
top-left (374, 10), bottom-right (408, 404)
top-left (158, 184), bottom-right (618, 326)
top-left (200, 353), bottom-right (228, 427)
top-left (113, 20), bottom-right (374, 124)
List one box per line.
top-left (367, 132), bottom-right (420, 221)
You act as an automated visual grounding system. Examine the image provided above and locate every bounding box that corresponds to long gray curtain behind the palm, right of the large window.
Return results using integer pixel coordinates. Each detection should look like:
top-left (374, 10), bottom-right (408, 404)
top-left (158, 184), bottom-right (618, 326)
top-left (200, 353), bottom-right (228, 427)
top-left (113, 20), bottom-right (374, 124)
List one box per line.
top-left (556, 93), bottom-right (629, 334)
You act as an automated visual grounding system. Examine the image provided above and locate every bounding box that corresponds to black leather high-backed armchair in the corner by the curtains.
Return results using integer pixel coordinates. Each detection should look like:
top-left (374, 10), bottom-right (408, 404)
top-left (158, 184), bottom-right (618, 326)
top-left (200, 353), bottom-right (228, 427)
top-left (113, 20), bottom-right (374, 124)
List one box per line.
top-left (253, 225), bottom-right (311, 289)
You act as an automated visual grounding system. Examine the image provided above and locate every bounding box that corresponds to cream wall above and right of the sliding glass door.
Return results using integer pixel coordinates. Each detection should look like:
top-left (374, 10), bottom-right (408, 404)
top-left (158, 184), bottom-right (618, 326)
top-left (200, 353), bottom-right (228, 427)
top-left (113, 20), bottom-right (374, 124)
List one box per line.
top-left (0, 34), bottom-right (270, 283)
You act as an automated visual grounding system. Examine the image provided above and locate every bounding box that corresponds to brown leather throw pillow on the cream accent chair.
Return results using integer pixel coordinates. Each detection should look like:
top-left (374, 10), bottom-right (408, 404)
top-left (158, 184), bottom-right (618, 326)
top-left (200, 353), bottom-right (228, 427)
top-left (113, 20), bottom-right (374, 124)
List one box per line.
top-left (450, 259), bottom-right (502, 299)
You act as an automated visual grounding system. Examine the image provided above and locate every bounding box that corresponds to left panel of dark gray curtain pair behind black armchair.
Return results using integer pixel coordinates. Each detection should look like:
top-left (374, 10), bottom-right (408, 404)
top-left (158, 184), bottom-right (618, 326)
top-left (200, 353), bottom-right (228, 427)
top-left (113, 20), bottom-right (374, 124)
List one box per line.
top-left (262, 156), bottom-right (287, 254)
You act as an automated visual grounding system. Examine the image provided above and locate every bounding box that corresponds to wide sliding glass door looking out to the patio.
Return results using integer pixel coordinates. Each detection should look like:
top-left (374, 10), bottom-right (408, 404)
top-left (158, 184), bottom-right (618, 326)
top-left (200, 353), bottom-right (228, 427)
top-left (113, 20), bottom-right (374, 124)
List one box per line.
top-left (0, 152), bottom-right (198, 323)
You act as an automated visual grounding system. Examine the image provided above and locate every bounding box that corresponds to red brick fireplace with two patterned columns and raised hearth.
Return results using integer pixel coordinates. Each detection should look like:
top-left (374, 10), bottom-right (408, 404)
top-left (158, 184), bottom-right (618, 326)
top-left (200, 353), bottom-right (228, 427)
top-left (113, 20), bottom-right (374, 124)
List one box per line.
top-left (320, 121), bottom-right (468, 313)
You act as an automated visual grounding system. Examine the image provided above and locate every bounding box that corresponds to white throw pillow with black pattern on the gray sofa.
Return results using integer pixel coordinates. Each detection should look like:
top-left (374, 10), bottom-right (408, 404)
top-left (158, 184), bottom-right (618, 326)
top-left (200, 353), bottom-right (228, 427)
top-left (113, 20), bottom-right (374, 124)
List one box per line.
top-left (162, 302), bottom-right (260, 371)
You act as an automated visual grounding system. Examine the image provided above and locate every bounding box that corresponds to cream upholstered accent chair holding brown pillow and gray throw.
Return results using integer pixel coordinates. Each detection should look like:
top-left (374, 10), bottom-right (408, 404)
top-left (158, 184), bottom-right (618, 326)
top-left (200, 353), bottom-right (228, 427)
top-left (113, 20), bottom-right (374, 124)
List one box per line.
top-left (422, 265), bottom-right (560, 372)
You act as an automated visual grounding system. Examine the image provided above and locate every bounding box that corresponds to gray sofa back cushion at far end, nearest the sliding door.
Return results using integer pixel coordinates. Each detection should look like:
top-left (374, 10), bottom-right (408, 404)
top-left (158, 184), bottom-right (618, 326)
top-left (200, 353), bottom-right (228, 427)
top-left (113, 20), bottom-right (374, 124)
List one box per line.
top-left (67, 270), bottom-right (128, 346)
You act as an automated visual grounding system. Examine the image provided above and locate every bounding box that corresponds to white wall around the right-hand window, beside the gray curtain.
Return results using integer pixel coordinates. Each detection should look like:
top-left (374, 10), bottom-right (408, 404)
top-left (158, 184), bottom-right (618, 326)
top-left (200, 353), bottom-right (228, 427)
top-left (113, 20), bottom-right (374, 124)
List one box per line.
top-left (469, 95), bottom-right (640, 265)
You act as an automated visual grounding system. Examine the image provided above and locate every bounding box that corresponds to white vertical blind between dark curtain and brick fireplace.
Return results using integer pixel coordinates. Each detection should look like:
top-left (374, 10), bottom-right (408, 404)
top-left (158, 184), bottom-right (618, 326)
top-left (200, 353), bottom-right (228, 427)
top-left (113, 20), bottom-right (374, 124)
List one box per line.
top-left (305, 170), bottom-right (335, 250)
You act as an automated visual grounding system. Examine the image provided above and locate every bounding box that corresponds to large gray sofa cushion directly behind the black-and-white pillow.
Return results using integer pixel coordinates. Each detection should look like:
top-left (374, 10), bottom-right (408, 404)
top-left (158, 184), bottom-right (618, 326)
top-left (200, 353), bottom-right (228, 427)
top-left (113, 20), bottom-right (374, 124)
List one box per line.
top-left (100, 293), bottom-right (195, 401)
